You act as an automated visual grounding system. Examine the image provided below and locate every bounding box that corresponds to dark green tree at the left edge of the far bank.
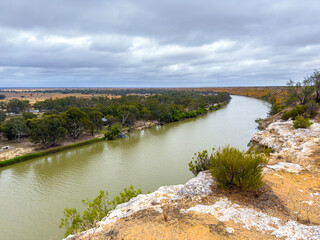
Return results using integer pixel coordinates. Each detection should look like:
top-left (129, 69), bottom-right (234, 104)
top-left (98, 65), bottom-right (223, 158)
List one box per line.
top-left (1, 117), bottom-right (28, 141)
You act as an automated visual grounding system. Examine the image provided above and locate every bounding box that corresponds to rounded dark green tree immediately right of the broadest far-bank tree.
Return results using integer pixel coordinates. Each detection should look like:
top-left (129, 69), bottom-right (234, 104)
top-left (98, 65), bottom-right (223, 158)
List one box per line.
top-left (63, 107), bottom-right (94, 139)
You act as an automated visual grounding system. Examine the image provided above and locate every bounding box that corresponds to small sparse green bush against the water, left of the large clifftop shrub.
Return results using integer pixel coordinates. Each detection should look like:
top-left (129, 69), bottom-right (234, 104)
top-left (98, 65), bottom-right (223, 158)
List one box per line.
top-left (189, 149), bottom-right (214, 176)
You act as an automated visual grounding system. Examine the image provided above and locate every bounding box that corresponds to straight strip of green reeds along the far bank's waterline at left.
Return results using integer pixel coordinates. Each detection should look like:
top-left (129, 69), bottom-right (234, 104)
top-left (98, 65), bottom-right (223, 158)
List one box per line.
top-left (0, 138), bottom-right (104, 167)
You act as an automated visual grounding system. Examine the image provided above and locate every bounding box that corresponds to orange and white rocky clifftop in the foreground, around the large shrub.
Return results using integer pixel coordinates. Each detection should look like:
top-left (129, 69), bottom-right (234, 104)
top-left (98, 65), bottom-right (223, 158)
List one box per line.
top-left (68, 113), bottom-right (320, 239)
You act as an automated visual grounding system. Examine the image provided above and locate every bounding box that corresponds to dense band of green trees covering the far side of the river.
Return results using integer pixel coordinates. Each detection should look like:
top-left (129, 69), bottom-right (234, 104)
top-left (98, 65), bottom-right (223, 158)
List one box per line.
top-left (0, 90), bottom-right (230, 147)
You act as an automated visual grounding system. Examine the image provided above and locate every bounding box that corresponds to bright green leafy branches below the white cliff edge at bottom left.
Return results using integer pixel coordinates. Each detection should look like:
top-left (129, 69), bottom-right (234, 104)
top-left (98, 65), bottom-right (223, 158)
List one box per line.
top-left (59, 185), bottom-right (142, 237)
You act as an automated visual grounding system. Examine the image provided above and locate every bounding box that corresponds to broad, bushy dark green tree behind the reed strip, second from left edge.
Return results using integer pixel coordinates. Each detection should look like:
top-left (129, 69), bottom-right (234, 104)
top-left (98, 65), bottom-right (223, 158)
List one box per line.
top-left (28, 115), bottom-right (68, 147)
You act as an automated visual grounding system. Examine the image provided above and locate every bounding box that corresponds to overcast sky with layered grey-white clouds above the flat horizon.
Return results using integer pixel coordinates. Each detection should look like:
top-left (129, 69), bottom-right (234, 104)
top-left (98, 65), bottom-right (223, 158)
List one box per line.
top-left (0, 0), bottom-right (320, 87)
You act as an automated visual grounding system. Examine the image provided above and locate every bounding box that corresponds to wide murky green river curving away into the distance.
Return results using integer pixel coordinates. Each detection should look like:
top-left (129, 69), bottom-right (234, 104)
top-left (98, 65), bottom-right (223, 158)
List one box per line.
top-left (0, 96), bottom-right (270, 240)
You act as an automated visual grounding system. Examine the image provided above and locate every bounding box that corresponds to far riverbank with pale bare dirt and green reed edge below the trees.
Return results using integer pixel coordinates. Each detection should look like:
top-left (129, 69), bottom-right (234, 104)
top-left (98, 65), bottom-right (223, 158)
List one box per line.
top-left (0, 102), bottom-right (228, 168)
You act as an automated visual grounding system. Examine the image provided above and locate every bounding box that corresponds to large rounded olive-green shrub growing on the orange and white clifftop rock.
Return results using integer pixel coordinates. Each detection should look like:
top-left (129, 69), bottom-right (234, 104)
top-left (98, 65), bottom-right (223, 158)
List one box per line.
top-left (210, 146), bottom-right (268, 190)
